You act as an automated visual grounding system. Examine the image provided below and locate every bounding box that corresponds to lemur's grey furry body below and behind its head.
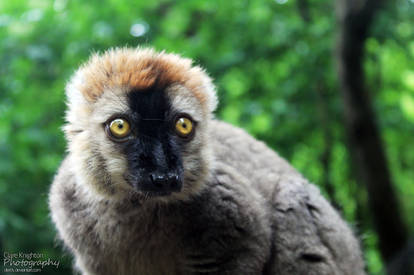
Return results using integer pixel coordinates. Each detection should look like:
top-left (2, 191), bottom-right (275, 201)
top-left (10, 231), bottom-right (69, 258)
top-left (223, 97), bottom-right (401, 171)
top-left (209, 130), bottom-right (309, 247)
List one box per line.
top-left (50, 121), bottom-right (364, 275)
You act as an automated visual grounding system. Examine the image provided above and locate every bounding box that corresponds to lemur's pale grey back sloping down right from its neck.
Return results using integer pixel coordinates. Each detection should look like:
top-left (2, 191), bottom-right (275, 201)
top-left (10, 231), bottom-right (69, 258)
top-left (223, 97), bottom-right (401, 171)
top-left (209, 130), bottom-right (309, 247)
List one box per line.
top-left (211, 121), bottom-right (364, 275)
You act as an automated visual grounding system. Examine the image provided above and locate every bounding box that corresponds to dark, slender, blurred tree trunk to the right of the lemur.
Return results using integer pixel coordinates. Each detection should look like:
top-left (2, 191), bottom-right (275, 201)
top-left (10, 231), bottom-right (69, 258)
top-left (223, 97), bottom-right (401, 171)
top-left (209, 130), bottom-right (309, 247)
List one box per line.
top-left (337, 0), bottom-right (407, 262)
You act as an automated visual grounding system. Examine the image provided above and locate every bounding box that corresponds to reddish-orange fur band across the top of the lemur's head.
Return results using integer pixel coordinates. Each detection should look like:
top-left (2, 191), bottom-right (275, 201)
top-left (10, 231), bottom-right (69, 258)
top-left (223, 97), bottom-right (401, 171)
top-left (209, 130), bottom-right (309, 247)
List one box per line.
top-left (79, 48), bottom-right (208, 104)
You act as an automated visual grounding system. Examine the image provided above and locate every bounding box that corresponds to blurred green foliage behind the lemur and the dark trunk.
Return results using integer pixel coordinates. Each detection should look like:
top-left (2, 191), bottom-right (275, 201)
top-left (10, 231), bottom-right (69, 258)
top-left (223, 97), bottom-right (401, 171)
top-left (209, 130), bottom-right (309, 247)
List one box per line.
top-left (0, 0), bottom-right (414, 274)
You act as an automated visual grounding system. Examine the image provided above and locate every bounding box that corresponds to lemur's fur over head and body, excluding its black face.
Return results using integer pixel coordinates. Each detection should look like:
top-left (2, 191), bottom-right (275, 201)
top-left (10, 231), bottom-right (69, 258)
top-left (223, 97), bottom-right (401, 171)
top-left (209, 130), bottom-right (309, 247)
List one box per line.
top-left (49, 48), bottom-right (364, 275)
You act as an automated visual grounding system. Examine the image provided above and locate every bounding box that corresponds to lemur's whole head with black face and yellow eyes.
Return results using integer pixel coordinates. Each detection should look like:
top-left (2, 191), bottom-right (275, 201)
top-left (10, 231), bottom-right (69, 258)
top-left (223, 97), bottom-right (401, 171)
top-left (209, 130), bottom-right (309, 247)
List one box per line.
top-left (64, 48), bottom-right (217, 203)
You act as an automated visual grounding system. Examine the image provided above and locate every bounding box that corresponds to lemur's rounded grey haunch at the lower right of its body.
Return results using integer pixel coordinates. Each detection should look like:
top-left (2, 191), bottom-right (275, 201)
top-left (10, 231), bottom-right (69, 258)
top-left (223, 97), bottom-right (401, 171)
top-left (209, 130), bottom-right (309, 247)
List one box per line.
top-left (271, 177), bottom-right (364, 275)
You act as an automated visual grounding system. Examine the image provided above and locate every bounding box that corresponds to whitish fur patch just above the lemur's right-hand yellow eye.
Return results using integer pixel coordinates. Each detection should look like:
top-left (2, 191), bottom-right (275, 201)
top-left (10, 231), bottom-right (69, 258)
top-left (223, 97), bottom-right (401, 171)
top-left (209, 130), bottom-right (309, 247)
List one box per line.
top-left (167, 85), bottom-right (205, 121)
